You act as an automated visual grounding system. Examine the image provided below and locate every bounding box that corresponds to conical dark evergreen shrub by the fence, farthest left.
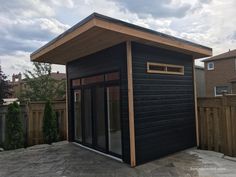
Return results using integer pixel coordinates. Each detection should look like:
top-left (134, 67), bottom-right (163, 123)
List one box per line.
top-left (4, 102), bottom-right (24, 150)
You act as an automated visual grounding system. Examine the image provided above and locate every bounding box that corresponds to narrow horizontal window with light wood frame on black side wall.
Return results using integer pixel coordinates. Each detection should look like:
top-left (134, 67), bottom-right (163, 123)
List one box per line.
top-left (147, 62), bottom-right (184, 75)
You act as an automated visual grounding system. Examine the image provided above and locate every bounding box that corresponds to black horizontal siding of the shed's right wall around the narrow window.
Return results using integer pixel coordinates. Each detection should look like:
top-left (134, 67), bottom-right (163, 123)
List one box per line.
top-left (132, 43), bottom-right (196, 164)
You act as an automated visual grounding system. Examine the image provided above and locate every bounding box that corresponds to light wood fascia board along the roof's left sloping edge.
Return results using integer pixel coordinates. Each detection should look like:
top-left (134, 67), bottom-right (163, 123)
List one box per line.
top-left (30, 19), bottom-right (95, 61)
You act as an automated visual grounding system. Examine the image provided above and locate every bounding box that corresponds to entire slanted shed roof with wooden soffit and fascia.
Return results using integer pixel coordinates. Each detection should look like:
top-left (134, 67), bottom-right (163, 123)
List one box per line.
top-left (30, 13), bottom-right (212, 65)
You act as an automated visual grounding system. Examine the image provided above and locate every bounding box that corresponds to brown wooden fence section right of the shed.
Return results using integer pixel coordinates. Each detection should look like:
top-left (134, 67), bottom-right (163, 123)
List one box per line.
top-left (198, 95), bottom-right (236, 157)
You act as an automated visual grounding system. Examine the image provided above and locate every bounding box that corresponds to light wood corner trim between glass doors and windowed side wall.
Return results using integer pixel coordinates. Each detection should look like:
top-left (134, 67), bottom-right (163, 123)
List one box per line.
top-left (126, 41), bottom-right (136, 167)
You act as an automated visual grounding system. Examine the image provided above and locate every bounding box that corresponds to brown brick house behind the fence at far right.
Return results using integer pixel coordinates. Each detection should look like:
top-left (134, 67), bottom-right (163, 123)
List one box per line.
top-left (203, 49), bottom-right (236, 96)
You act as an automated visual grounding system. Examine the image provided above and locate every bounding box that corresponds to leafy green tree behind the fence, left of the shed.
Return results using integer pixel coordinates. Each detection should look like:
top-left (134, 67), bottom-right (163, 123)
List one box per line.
top-left (20, 62), bottom-right (66, 101)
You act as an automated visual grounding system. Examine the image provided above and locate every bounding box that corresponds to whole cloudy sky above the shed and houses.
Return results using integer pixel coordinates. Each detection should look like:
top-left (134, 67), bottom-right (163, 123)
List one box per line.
top-left (0, 0), bottom-right (236, 79)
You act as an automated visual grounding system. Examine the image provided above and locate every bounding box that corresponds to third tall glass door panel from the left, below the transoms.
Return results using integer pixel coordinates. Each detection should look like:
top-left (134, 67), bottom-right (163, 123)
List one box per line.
top-left (94, 87), bottom-right (106, 150)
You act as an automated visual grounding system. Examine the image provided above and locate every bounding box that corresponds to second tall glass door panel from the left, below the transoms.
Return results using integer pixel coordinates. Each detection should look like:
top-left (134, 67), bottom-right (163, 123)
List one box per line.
top-left (84, 89), bottom-right (93, 145)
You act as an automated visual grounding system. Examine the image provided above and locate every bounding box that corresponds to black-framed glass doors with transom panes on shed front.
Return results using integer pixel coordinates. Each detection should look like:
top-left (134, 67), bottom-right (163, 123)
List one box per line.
top-left (72, 72), bottom-right (122, 157)
